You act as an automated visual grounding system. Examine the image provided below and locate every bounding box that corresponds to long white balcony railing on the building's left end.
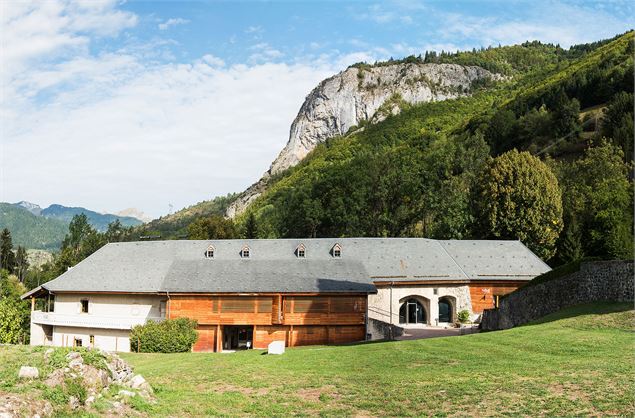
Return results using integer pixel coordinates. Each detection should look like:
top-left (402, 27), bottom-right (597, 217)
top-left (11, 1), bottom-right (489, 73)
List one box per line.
top-left (31, 311), bottom-right (162, 329)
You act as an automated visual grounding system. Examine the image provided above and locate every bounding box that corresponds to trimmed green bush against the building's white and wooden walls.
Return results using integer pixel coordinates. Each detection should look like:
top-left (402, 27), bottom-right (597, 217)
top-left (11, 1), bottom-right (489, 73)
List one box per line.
top-left (130, 318), bottom-right (198, 353)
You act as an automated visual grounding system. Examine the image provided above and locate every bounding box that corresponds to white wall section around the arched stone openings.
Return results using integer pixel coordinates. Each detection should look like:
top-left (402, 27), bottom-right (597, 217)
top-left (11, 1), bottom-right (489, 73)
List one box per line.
top-left (368, 285), bottom-right (472, 326)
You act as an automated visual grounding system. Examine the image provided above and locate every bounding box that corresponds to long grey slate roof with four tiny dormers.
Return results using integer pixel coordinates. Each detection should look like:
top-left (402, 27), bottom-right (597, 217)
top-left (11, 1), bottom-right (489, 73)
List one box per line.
top-left (43, 238), bottom-right (549, 293)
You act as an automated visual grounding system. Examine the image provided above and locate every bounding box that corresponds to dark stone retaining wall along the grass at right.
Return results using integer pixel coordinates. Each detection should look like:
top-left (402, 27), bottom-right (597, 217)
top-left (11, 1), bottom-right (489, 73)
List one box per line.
top-left (481, 261), bottom-right (635, 331)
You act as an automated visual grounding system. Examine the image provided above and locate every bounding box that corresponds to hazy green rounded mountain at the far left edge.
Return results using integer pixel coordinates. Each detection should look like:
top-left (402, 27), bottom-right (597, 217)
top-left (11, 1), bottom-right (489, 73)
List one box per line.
top-left (0, 203), bottom-right (68, 250)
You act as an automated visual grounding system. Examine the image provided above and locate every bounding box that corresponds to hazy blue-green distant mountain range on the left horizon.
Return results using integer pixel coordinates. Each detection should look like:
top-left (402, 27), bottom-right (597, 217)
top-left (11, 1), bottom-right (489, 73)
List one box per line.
top-left (0, 201), bottom-right (143, 250)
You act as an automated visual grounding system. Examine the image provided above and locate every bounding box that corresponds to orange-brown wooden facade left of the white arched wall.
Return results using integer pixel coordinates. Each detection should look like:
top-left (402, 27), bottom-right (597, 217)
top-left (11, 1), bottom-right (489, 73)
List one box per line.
top-left (168, 294), bottom-right (367, 351)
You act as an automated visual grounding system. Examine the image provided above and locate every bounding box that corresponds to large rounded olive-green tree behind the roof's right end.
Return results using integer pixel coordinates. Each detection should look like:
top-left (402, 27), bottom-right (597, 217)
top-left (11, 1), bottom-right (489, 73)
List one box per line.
top-left (475, 150), bottom-right (562, 259)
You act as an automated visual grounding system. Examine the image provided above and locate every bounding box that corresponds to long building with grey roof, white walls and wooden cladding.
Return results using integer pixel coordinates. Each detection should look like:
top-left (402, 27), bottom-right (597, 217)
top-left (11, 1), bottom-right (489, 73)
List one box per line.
top-left (23, 238), bottom-right (549, 351)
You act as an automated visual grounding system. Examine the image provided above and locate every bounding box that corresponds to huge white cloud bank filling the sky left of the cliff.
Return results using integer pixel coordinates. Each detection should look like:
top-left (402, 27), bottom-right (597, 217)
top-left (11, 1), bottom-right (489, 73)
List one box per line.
top-left (0, 3), bottom-right (337, 216)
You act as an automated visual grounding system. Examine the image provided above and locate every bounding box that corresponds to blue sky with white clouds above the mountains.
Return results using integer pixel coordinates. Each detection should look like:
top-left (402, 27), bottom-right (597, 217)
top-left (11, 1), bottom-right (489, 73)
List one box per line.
top-left (0, 0), bottom-right (634, 217)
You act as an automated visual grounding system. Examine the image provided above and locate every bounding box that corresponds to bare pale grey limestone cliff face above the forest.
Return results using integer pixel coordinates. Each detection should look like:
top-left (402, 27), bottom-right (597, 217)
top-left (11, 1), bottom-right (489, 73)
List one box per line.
top-left (227, 64), bottom-right (500, 217)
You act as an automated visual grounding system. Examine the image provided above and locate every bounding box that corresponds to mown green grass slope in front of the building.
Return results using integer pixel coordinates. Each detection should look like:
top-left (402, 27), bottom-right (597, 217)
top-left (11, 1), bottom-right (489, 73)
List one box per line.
top-left (120, 304), bottom-right (635, 416)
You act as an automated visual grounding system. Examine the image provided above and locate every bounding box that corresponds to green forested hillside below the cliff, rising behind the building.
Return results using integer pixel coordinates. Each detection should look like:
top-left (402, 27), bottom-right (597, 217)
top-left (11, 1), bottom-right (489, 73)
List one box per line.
top-left (238, 32), bottom-right (634, 262)
